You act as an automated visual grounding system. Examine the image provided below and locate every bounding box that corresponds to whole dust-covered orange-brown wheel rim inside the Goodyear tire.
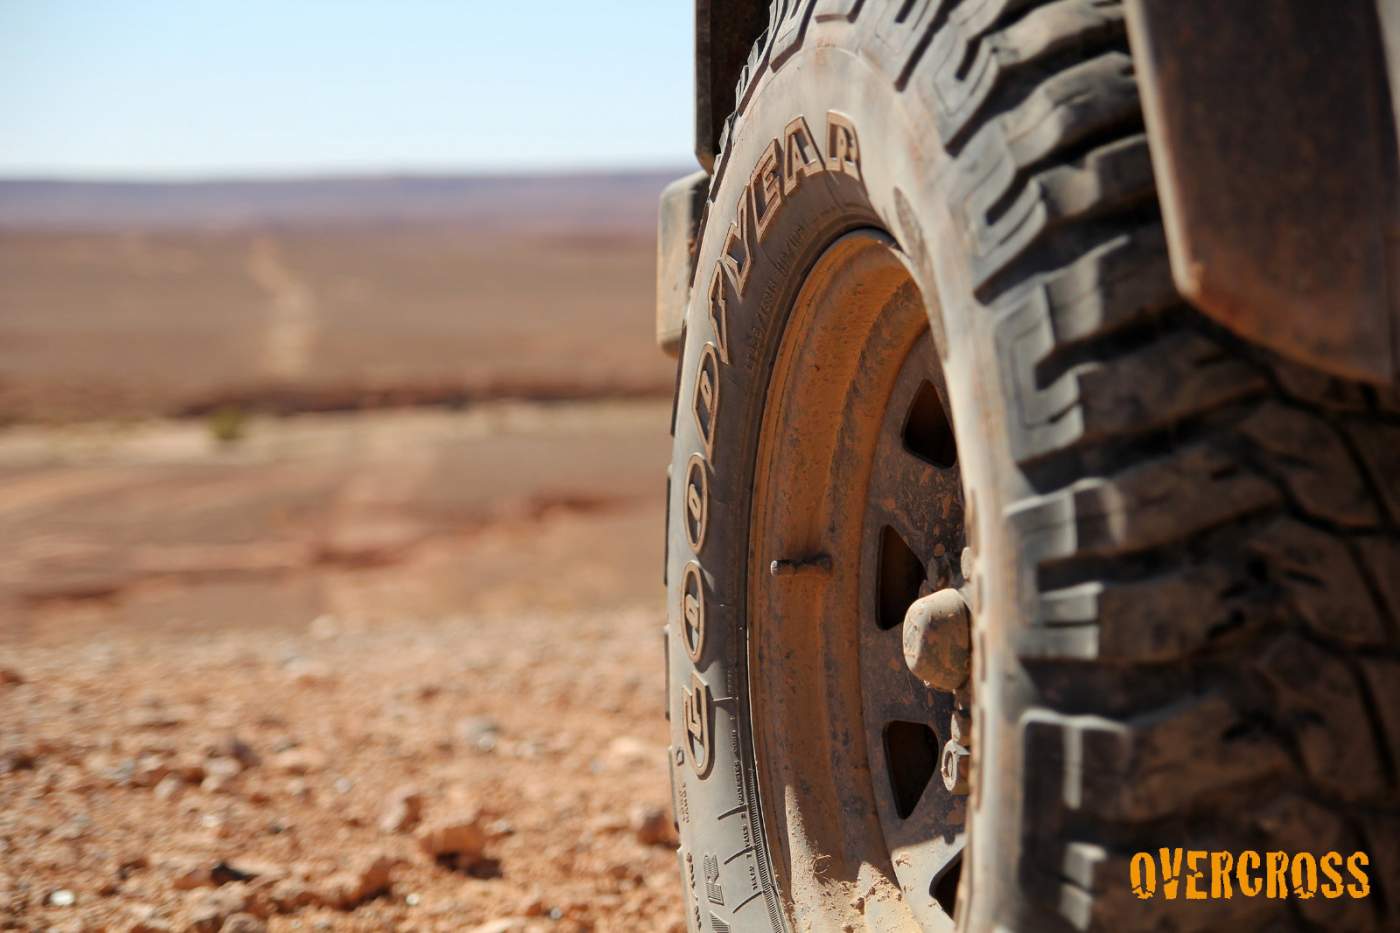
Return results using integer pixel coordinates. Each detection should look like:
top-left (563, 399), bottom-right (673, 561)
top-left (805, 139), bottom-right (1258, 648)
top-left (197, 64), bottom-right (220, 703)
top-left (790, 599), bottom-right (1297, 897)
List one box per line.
top-left (748, 231), bottom-right (966, 930)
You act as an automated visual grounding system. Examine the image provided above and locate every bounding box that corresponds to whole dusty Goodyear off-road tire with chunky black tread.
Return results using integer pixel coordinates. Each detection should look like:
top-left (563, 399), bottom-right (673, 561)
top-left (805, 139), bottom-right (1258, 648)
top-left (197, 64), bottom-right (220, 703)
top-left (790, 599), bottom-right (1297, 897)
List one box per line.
top-left (666, 0), bottom-right (1400, 930)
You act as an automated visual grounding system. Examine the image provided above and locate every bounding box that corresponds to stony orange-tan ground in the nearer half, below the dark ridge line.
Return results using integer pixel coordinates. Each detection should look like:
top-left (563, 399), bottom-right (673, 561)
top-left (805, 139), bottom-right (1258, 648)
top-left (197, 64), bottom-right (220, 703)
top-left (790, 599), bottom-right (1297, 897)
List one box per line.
top-left (0, 402), bottom-right (683, 932)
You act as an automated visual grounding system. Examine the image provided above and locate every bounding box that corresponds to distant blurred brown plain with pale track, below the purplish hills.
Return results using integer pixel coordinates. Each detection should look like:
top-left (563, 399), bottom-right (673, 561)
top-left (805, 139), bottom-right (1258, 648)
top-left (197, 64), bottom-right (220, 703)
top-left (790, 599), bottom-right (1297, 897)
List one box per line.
top-left (0, 228), bottom-right (675, 424)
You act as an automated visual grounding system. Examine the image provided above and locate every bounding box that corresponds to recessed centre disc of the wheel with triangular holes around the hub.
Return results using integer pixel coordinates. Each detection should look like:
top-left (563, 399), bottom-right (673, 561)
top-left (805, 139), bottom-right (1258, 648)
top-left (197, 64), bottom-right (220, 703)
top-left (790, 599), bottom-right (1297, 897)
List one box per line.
top-left (857, 333), bottom-right (967, 916)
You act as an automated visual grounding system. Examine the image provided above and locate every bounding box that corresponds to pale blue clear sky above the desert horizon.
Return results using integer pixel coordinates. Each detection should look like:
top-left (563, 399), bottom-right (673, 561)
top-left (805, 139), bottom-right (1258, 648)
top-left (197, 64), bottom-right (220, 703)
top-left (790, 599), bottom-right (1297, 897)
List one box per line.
top-left (0, 0), bottom-right (693, 177)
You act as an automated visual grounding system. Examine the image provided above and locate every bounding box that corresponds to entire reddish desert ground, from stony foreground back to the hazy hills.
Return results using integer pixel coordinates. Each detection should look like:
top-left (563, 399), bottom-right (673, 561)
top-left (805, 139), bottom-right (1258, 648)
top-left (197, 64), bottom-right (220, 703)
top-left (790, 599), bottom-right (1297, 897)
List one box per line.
top-left (0, 178), bottom-right (683, 932)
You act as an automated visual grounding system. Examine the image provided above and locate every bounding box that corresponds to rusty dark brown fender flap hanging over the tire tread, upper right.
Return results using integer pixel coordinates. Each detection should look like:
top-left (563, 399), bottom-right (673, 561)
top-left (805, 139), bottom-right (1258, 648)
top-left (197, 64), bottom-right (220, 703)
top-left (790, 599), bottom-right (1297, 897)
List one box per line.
top-left (1127, 0), bottom-right (1400, 384)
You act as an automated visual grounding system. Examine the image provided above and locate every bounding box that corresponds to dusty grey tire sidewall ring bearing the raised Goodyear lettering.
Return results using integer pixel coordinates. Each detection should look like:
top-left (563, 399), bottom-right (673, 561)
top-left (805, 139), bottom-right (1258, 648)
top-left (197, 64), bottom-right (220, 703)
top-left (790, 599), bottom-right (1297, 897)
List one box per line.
top-left (666, 38), bottom-right (1023, 930)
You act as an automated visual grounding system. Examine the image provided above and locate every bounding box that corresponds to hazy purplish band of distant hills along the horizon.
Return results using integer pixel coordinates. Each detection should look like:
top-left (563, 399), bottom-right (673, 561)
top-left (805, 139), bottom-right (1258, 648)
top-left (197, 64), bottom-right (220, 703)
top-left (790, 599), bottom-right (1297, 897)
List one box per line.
top-left (0, 167), bottom-right (687, 231)
